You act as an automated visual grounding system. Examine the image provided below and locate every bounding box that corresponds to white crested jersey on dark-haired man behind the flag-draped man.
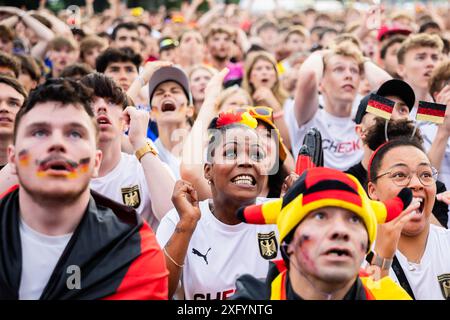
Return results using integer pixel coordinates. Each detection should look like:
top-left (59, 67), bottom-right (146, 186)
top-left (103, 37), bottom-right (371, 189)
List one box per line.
top-left (90, 152), bottom-right (159, 231)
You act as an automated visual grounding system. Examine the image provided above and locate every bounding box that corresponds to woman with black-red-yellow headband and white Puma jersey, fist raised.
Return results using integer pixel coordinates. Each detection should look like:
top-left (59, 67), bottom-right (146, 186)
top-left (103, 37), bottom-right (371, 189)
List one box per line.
top-left (157, 112), bottom-right (278, 300)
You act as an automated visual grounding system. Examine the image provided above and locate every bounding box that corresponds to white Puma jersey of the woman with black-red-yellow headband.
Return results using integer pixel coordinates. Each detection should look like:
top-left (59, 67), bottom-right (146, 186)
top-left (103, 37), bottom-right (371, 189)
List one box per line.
top-left (156, 199), bottom-right (279, 300)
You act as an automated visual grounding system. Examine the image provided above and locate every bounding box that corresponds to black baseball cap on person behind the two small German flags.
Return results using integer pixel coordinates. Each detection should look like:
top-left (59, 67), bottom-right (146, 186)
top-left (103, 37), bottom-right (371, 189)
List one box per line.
top-left (355, 79), bottom-right (416, 124)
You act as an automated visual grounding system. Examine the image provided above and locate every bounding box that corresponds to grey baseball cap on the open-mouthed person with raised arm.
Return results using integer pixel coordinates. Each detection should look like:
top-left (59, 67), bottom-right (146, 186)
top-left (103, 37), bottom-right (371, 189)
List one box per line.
top-left (148, 67), bottom-right (193, 105)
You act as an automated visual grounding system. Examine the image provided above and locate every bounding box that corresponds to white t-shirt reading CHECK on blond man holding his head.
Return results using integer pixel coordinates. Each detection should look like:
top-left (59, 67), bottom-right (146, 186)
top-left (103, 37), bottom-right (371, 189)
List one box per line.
top-left (284, 104), bottom-right (363, 171)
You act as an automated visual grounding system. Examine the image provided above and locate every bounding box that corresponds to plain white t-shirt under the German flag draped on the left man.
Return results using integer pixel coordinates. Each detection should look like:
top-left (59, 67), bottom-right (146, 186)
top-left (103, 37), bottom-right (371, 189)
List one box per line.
top-left (19, 219), bottom-right (72, 300)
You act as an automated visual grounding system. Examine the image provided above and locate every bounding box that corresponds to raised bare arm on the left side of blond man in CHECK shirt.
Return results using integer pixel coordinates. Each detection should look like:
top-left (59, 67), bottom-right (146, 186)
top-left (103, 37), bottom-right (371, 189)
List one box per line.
top-left (294, 51), bottom-right (324, 126)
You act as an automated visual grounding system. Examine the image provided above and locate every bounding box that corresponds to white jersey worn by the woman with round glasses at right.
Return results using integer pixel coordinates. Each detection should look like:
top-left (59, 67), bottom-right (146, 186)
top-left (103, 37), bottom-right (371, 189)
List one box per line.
top-left (389, 224), bottom-right (450, 300)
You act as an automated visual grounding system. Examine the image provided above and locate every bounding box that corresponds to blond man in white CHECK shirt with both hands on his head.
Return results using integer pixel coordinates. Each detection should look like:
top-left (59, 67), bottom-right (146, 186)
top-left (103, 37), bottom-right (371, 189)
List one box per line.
top-left (285, 42), bottom-right (390, 170)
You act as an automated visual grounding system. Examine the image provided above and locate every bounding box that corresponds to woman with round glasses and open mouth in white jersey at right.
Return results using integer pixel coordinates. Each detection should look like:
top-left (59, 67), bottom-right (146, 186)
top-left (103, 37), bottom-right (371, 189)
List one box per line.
top-left (368, 138), bottom-right (450, 300)
